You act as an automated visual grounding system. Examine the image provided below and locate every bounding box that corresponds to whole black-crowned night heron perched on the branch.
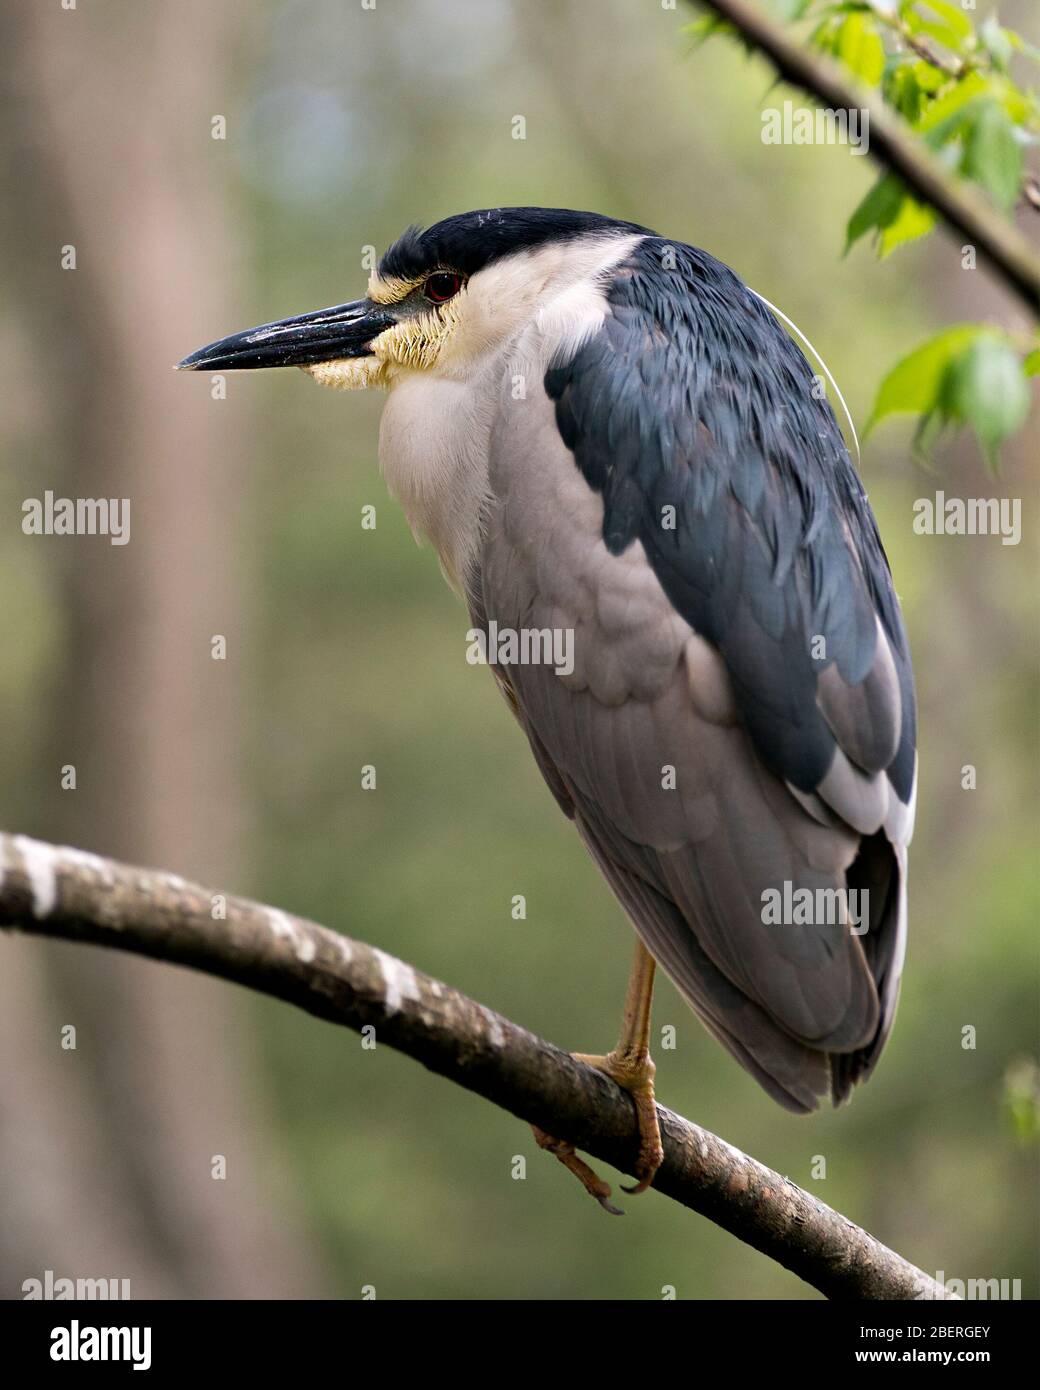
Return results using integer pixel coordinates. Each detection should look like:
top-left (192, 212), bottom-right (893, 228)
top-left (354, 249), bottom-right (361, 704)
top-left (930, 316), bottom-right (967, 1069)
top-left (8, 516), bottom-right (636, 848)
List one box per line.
top-left (181, 207), bottom-right (915, 1207)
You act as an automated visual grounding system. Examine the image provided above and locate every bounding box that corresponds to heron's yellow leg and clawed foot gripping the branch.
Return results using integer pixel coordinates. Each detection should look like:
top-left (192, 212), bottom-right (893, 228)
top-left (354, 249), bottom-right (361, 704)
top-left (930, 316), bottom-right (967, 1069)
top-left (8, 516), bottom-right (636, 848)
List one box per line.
top-left (534, 937), bottom-right (665, 1215)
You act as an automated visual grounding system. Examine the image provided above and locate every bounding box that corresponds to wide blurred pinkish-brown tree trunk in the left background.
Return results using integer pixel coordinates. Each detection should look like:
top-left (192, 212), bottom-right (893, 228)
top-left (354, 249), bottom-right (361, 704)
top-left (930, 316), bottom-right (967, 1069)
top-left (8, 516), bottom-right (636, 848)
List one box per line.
top-left (0, 0), bottom-right (320, 1298)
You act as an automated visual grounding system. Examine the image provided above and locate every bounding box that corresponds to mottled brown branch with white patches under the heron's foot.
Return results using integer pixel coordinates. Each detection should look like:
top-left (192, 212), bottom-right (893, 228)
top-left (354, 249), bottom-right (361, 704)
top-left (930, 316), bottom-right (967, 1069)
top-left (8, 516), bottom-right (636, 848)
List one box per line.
top-left (0, 834), bottom-right (951, 1298)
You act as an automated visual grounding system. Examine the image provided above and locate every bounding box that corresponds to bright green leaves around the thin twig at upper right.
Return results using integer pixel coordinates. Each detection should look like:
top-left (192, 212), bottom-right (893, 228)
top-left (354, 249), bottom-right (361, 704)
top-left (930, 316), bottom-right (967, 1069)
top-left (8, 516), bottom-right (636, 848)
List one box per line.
top-left (690, 0), bottom-right (1040, 463)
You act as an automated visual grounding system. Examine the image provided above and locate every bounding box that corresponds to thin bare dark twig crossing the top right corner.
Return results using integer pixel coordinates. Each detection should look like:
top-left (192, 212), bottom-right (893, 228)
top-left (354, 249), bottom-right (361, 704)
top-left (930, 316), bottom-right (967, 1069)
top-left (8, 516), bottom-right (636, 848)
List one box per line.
top-left (692, 0), bottom-right (1040, 314)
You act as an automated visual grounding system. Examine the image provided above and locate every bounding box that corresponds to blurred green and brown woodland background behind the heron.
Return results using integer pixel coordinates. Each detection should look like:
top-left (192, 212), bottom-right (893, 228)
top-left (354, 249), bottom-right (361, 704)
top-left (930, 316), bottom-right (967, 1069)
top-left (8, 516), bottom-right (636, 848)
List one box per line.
top-left (0, 0), bottom-right (1040, 1300)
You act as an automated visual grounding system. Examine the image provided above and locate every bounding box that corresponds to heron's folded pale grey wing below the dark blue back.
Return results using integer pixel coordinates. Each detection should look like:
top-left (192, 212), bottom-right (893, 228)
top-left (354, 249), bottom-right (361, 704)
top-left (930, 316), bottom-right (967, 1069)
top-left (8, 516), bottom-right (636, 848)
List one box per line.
top-left (470, 366), bottom-right (909, 1111)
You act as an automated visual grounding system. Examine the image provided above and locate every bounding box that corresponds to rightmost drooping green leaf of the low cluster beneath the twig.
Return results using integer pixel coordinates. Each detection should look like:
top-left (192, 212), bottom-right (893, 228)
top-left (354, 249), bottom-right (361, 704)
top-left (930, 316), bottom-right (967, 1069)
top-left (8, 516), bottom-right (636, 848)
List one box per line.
top-left (940, 334), bottom-right (1029, 463)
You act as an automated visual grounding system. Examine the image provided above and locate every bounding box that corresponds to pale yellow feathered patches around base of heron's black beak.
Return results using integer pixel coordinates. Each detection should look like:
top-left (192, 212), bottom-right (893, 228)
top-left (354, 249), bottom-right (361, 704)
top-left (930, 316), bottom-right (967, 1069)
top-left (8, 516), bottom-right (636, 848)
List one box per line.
top-left (302, 275), bottom-right (466, 391)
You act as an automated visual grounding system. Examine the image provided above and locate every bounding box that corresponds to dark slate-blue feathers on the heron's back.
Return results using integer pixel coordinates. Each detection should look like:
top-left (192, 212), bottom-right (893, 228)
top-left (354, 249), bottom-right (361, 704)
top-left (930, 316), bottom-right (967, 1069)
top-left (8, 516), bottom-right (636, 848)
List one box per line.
top-left (545, 236), bottom-right (915, 801)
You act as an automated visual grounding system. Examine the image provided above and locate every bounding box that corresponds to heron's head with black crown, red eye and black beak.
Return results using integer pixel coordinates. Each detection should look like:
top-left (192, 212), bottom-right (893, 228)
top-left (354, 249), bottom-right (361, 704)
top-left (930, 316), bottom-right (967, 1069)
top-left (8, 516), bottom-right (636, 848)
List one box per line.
top-left (178, 207), bottom-right (647, 389)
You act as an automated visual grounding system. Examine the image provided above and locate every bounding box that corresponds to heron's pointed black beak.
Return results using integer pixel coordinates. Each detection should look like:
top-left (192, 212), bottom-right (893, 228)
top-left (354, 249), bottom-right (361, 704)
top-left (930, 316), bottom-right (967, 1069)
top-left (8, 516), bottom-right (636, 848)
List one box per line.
top-left (177, 299), bottom-right (396, 371)
